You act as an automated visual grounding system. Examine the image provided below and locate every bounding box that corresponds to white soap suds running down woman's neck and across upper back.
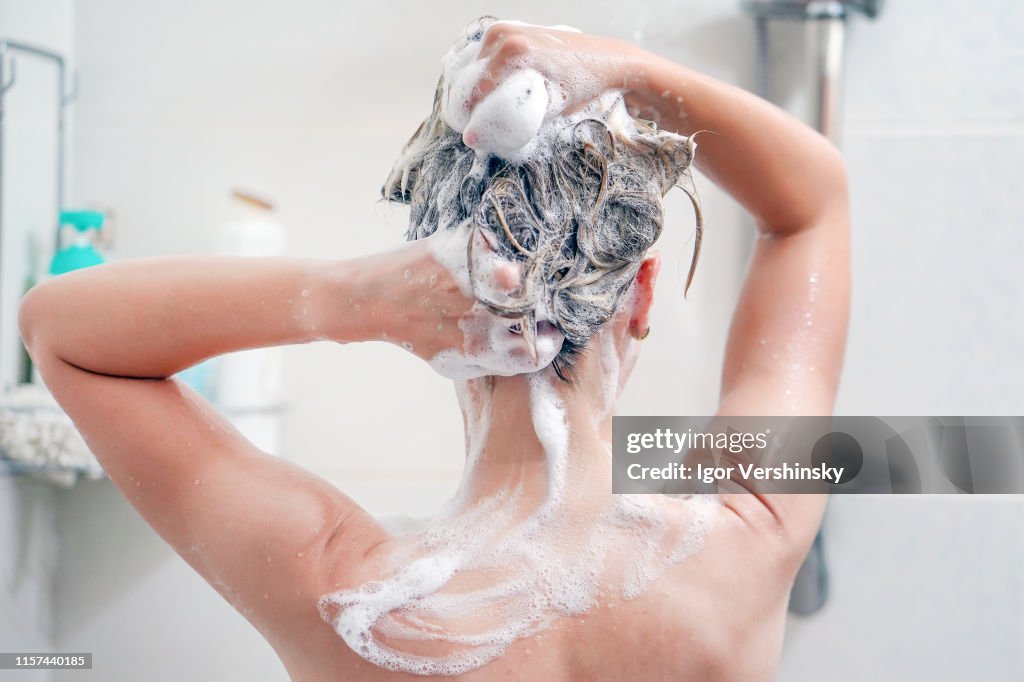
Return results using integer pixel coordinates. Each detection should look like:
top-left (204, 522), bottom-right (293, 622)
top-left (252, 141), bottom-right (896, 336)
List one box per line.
top-left (319, 369), bottom-right (719, 676)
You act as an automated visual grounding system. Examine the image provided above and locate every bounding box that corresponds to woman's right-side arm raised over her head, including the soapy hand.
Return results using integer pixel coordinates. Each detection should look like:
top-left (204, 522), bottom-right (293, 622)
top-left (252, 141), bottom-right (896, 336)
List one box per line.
top-left (466, 24), bottom-right (850, 540)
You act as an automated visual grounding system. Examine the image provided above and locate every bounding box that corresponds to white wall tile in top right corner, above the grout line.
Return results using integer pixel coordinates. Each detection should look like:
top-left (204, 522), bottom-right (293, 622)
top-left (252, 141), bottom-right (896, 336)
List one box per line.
top-left (846, 0), bottom-right (1024, 124)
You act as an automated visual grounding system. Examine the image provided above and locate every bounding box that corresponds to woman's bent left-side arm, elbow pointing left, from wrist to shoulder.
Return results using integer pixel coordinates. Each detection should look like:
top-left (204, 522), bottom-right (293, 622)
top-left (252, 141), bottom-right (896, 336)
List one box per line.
top-left (19, 240), bottom-right (479, 642)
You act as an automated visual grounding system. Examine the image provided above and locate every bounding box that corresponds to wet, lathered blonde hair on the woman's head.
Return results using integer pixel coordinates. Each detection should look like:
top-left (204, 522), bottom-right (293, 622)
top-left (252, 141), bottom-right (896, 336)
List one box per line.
top-left (382, 19), bottom-right (701, 380)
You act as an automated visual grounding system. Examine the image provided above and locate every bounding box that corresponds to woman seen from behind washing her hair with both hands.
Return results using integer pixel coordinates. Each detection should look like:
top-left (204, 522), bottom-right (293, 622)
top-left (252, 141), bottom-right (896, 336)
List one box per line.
top-left (20, 20), bottom-right (849, 682)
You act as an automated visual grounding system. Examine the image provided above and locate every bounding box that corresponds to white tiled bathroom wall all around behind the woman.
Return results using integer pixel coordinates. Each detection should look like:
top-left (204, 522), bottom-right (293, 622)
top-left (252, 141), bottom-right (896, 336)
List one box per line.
top-left (0, 0), bottom-right (1024, 682)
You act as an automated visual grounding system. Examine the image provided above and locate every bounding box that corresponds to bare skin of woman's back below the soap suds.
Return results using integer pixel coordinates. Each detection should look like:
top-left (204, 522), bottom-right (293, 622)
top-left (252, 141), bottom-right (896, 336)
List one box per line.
top-left (273, 496), bottom-right (820, 682)
